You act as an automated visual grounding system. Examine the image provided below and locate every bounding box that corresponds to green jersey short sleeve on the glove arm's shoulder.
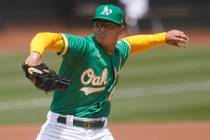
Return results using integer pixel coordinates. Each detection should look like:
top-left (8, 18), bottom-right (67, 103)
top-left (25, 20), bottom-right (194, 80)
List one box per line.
top-left (61, 34), bottom-right (88, 55)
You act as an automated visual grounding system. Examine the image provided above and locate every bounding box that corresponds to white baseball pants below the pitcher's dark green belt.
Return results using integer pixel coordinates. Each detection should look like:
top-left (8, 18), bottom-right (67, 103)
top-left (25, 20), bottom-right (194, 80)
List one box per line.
top-left (36, 111), bottom-right (114, 140)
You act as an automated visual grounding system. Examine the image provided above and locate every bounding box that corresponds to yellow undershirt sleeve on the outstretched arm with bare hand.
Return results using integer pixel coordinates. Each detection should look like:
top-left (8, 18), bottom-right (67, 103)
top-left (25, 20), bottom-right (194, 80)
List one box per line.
top-left (124, 32), bottom-right (166, 53)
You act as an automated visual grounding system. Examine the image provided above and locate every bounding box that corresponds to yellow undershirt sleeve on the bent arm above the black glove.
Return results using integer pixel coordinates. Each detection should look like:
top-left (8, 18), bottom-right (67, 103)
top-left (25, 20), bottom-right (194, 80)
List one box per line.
top-left (30, 32), bottom-right (67, 55)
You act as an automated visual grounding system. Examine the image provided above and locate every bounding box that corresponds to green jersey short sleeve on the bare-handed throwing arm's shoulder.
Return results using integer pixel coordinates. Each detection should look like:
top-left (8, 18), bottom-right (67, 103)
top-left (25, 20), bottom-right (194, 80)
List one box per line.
top-left (116, 39), bottom-right (131, 67)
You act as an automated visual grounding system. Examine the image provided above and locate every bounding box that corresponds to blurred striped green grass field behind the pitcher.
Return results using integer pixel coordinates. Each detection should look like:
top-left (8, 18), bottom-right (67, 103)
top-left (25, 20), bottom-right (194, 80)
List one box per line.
top-left (0, 45), bottom-right (210, 124)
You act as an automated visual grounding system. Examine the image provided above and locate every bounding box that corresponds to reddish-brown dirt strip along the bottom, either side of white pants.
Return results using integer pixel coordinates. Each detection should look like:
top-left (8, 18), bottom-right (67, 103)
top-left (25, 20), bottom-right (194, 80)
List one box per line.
top-left (0, 122), bottom-right (210, 140)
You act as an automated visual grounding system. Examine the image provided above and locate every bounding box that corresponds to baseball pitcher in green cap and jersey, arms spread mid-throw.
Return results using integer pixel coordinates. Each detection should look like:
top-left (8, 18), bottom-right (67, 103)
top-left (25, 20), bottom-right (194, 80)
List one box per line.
top-left (22, 4), bottom-right (189, 140)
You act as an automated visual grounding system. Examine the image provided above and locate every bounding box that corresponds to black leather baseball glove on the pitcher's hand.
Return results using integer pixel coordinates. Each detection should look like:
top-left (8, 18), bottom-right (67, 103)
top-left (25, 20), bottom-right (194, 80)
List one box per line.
top-left (22, 63), bottom-right (70, 93)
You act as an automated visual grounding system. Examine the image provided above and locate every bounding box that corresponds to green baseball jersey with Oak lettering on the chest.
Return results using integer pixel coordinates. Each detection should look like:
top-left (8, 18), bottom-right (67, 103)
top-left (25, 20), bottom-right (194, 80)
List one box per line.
top-left (50, 34), bottom-right (130, 118)
